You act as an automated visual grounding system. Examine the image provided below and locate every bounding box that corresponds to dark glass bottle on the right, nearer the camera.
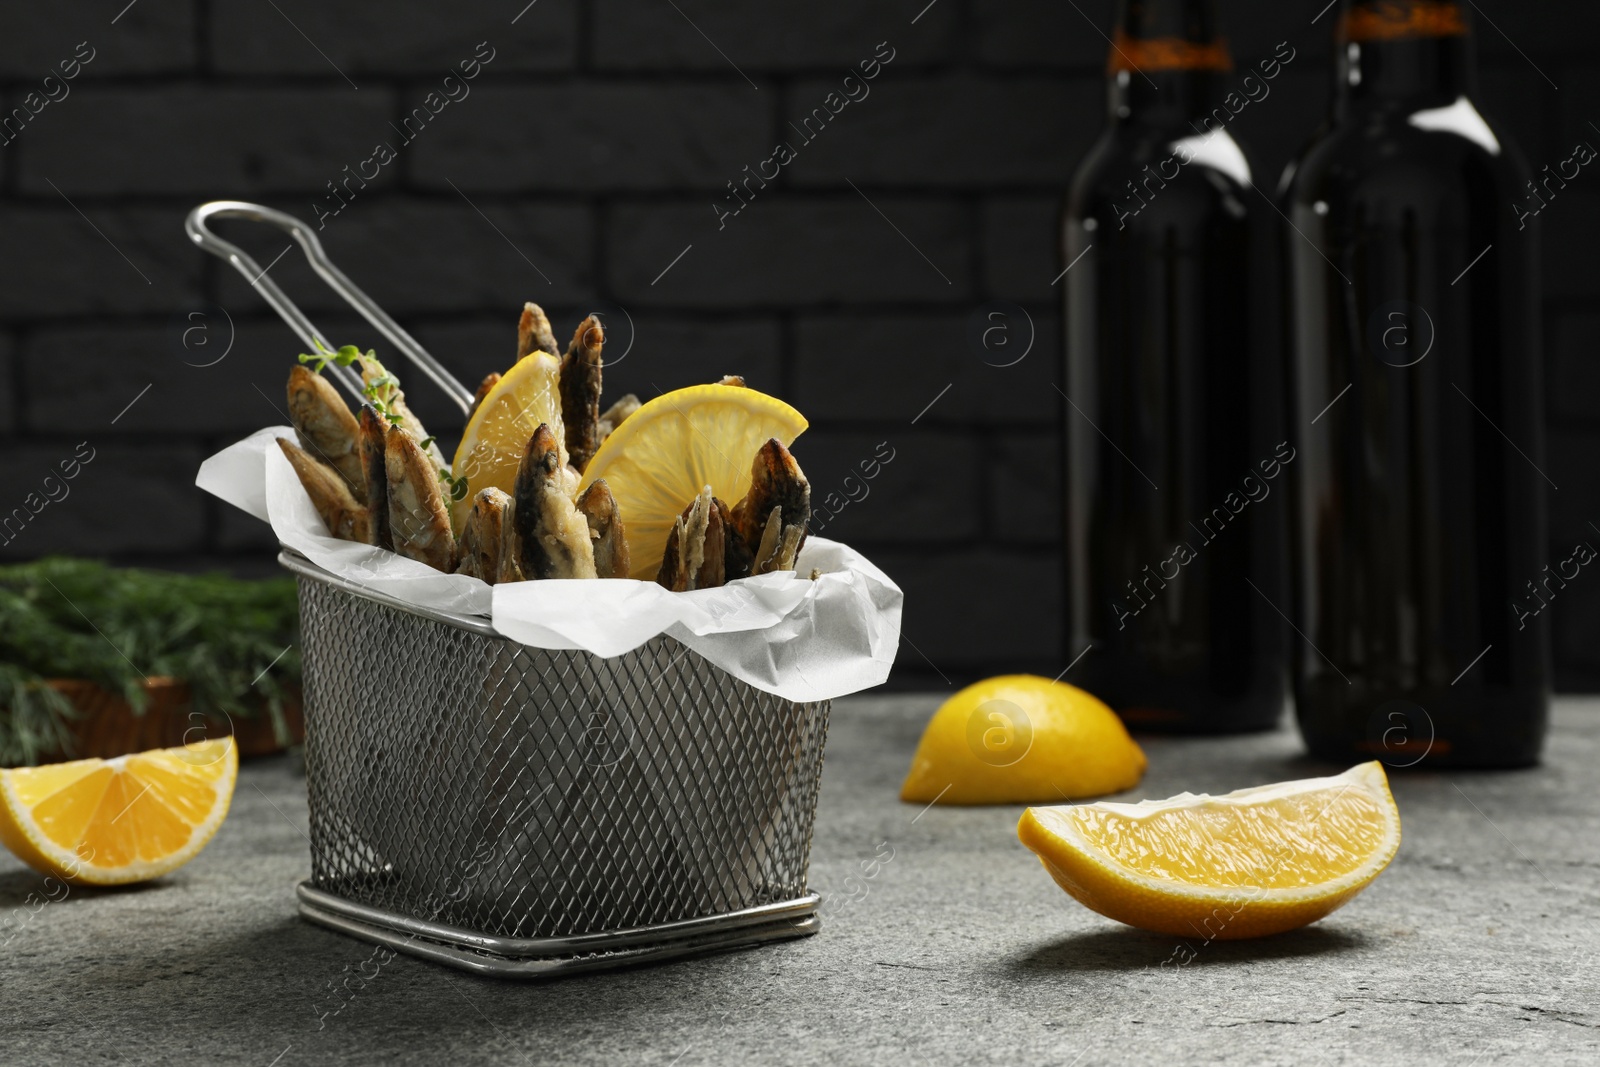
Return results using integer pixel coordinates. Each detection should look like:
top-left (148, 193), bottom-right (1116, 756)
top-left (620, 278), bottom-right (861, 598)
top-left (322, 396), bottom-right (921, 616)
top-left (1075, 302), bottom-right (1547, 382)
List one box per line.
top-left (1283, 0), bottom-right (1558, 766)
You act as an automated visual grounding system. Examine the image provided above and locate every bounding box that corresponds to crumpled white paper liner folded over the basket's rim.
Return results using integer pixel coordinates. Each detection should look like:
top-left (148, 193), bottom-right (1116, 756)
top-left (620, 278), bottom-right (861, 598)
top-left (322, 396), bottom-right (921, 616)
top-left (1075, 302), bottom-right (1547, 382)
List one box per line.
top-left (195, 426), bottom-right (904, 701)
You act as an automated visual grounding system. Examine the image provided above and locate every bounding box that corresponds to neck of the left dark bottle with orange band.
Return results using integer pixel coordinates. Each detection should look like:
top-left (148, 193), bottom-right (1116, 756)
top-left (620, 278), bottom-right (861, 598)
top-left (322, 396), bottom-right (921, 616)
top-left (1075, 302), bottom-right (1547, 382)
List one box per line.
top-left (1106, 0), bottom-right (1234, 125)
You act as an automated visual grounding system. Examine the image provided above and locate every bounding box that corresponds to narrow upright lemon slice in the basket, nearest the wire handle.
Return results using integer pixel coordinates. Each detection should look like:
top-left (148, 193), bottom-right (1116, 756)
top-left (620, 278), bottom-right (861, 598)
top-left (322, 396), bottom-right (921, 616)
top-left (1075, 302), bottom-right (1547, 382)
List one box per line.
top-left (450, 352), bottom-right (566, 534)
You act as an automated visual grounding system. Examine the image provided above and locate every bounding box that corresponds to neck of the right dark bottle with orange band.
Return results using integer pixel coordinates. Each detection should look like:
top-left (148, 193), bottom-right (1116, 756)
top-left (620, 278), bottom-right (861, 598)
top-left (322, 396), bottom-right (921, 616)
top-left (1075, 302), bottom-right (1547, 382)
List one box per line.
top-left (1334, 0), bottom-right (1477, 114)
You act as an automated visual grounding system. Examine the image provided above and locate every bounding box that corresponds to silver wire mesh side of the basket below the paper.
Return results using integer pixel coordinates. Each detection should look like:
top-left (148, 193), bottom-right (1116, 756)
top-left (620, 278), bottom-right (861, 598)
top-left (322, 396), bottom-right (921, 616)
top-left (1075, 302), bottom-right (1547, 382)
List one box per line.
top-left (299, 577), bottom-right (829, 937)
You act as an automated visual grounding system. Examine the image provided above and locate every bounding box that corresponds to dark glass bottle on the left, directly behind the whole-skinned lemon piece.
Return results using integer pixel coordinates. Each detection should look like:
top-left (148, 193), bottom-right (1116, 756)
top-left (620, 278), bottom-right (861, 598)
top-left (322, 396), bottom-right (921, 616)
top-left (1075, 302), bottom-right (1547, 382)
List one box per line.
top-left (1061, 0), bottom-right (1286, 733)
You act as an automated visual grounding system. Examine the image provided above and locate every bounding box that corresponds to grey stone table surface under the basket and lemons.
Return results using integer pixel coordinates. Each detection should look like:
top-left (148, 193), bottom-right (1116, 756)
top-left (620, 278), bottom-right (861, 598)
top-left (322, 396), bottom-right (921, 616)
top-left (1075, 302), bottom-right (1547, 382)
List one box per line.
top-left (0, 696), bottom-right (1600, 1067)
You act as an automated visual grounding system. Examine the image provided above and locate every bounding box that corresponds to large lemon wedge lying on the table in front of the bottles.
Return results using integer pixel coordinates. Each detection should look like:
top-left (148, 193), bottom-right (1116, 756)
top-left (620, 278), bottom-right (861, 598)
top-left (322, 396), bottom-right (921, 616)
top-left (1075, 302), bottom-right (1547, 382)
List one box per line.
top-left (1016, 761), bottom-right (1400, 941)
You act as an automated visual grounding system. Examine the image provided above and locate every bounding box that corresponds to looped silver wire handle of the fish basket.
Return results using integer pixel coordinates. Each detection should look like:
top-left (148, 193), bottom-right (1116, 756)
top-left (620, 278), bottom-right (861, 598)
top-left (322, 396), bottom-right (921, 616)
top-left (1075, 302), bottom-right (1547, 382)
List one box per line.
top-left (184, 200), bottom-right (472, 414)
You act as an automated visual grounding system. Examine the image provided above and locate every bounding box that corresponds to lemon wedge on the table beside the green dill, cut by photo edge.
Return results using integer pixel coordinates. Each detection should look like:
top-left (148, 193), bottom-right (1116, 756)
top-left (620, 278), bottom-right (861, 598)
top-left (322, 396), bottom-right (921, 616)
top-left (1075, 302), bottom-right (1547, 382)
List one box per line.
top-left (0, 737), bottom-right (238, 886)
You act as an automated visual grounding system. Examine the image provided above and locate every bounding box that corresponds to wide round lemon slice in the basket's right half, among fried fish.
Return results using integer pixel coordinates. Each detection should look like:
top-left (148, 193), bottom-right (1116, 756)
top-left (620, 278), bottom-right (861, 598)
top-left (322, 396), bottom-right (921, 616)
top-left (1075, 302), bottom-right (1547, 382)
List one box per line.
top-left (578, 386), bottom-right (808, 581)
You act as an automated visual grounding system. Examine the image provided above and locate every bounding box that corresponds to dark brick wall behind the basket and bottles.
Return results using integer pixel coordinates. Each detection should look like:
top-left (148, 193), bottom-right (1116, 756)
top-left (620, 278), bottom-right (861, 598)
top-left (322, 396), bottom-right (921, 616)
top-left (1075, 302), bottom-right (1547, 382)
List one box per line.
top-left (0, 0), bottom-right (1600, 688)
